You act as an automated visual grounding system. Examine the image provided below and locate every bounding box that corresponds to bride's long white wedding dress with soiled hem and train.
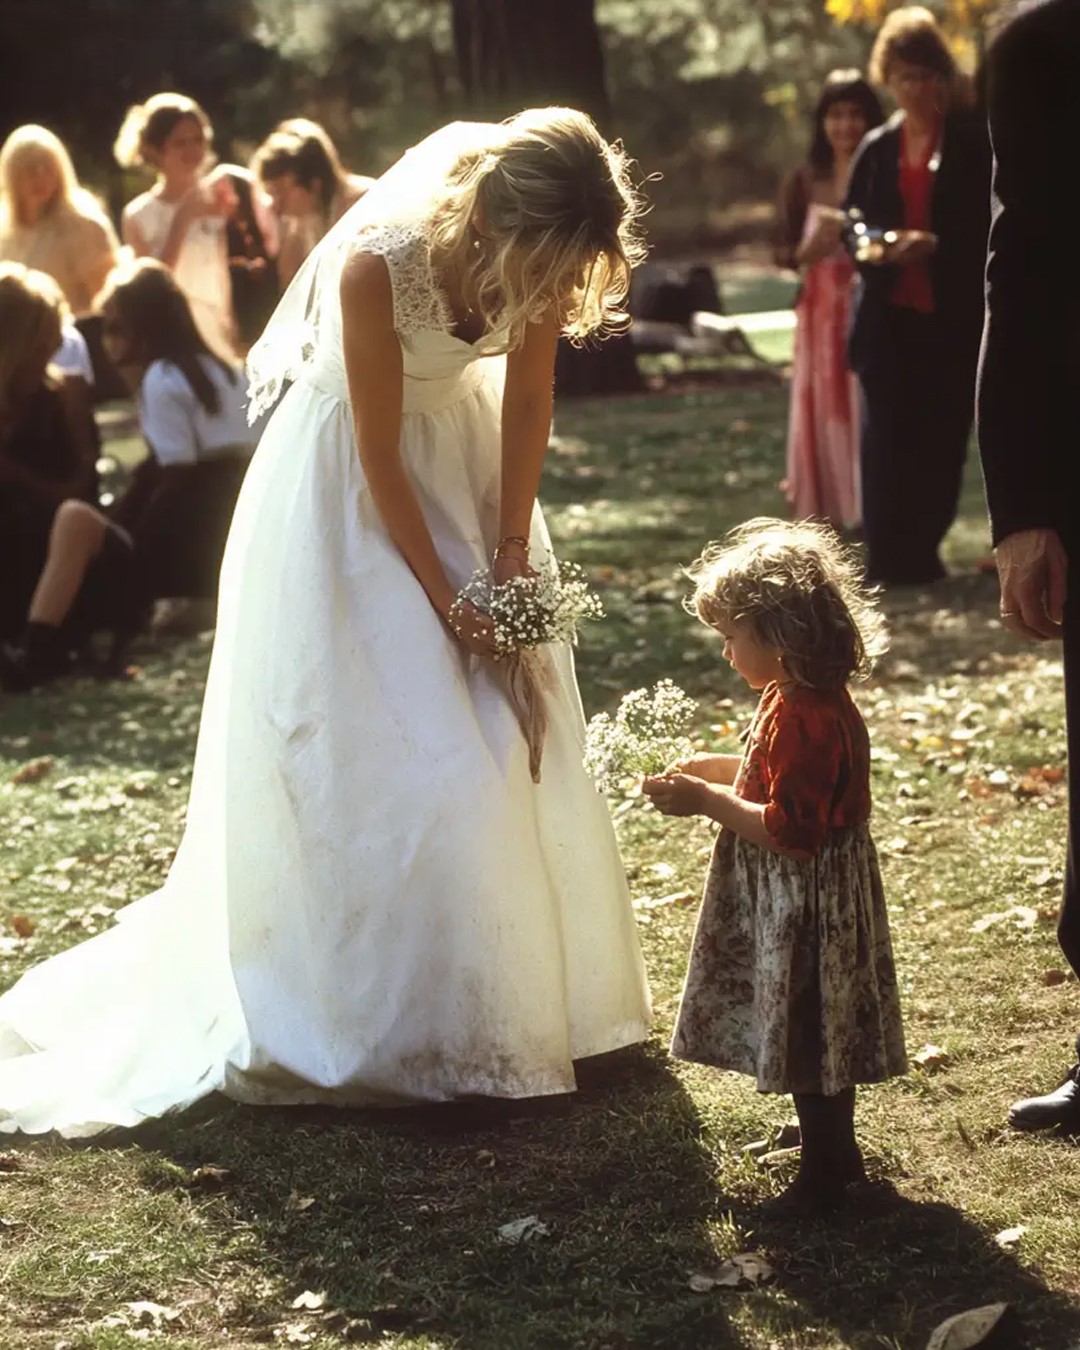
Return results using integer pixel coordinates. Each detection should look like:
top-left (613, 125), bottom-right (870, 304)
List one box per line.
top-left (0, 127), bottom-right (648, 1135)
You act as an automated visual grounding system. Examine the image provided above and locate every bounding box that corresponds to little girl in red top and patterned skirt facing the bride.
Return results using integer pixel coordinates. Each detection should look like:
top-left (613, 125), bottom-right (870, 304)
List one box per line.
top-left (644, 520), bottom-right (907, 1212)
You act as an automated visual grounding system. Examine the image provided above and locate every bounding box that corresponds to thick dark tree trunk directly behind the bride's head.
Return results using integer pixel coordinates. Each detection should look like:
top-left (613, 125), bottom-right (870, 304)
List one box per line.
top-left (451, 0), bottom-right (643, 394)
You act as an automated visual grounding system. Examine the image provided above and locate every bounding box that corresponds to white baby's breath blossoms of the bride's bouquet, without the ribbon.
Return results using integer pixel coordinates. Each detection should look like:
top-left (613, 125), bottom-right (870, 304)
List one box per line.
top-left (460, 558), bottom-right (603, 656)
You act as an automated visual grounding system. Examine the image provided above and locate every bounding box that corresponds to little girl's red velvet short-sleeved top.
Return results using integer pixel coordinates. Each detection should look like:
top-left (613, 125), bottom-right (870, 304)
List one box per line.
top-left (734, 683), bottom-right (871, 857)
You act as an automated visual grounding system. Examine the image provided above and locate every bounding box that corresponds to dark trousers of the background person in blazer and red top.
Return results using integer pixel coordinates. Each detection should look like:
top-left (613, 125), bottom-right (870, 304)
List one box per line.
top-left (859, 305), bottom-right (976, 586)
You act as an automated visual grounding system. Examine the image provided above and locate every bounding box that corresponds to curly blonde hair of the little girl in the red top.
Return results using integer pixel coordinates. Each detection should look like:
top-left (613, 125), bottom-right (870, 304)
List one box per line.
top-left (687, 516), bottom-right (888, 690)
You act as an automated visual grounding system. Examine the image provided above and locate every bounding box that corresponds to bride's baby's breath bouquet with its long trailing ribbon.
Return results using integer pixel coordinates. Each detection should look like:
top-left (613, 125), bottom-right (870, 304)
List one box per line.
top-left (450, 558), bottom-right (603, 783)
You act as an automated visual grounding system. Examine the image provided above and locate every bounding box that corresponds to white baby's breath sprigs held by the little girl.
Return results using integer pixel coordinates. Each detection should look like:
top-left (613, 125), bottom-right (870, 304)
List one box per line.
top-left (585, 679), bottom-right (697, 792)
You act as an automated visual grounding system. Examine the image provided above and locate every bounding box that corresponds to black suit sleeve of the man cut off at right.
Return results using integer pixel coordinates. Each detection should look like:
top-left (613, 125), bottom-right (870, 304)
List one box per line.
top-left (977, 18), bottom-right (1072, 544)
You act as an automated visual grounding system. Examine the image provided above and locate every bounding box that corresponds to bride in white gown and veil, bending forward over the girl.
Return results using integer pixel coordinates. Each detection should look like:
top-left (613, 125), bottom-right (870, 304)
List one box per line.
top-left (0, 108), bottom-right (648, 1135)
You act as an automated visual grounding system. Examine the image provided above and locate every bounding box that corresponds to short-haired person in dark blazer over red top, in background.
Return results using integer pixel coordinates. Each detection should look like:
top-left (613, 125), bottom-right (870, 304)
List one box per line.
top-left (845, 5), bottom-right (990, 585)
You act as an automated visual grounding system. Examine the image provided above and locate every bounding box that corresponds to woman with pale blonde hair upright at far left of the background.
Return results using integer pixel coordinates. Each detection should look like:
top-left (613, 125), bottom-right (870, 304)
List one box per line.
top-left (0, 126), bottom-right (119, 319)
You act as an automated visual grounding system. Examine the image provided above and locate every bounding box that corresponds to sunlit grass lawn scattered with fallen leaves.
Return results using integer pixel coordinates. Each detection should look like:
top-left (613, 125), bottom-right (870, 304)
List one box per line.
top-left (0, 389), bottom-right (1080, 1350)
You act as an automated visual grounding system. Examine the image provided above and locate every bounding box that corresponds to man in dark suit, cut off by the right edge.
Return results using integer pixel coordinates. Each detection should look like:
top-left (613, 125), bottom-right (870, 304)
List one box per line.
top-left (979, 0), bottom-right (1080, 1130)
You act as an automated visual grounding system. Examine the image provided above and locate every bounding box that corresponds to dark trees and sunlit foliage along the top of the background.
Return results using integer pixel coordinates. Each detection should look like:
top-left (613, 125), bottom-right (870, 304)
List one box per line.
top-left (0, 0), bottom-right (994, 248)
